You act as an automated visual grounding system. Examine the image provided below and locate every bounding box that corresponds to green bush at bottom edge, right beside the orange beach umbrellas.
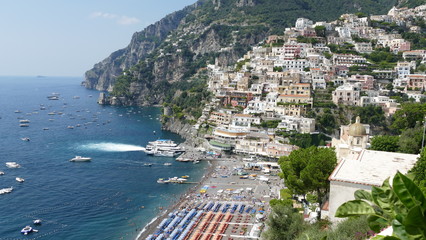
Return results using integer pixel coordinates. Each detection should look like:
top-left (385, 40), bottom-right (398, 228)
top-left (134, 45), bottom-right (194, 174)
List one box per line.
top-left (262, 204), bottom-right (306, 240)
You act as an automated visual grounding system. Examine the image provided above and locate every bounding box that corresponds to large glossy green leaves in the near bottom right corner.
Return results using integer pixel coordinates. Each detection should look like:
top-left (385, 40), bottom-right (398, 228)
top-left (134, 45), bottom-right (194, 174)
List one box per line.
top-left (336, 172), bottom-right (426, 240)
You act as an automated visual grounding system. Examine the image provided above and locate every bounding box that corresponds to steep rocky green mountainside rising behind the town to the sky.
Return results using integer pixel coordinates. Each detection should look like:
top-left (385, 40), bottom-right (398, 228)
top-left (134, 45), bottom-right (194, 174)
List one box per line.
top-left (86, 0), bottom-right (397, 105)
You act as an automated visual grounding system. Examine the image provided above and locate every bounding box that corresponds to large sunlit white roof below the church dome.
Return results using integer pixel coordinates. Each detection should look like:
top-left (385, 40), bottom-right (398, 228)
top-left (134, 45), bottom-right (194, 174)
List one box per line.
top-left (329, 149), bottom-right (419, 186)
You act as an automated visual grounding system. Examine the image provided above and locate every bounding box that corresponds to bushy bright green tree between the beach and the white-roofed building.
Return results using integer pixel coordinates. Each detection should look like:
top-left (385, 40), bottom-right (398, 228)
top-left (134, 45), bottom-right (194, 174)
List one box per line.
top-left (278, 147), bottom-right (337, 219)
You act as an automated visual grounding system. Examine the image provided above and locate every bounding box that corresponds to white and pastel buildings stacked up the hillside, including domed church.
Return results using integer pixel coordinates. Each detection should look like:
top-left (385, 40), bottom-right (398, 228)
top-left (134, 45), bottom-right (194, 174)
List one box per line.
top-left (186, 5), bottom-right (426, 225)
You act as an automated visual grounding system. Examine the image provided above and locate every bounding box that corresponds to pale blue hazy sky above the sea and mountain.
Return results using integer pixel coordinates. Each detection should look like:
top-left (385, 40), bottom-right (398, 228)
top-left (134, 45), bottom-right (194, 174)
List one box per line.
top-left (0, 0), bottom-right (196, 76)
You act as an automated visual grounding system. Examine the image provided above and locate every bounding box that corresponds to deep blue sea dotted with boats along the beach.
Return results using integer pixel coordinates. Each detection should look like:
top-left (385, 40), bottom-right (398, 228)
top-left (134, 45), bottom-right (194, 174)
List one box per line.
top-left (0, 77), bottom-right (208, 240)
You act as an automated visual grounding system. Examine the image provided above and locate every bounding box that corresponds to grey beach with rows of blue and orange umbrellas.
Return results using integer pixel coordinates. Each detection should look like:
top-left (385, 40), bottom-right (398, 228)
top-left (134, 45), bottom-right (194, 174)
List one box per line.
top-left (137, 152), bottom-right (282, 240)
